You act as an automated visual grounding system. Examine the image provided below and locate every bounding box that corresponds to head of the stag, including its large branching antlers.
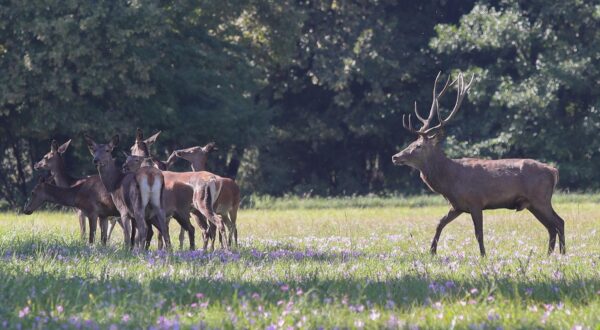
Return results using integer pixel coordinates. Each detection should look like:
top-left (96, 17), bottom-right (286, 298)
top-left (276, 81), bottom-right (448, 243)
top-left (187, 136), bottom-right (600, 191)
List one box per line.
top-left (392, 72), bottom-right (474, 169)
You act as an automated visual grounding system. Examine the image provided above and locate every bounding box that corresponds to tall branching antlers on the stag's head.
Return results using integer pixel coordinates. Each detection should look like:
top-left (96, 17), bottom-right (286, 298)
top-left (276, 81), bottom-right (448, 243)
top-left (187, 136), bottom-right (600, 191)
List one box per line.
top-left (402, 72), bottom-right (475, 136)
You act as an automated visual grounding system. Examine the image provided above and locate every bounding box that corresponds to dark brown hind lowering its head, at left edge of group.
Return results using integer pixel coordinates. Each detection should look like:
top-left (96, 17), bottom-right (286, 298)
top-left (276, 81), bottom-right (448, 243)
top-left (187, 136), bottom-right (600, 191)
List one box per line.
top-left (23, 178), bottom-right (123, 245)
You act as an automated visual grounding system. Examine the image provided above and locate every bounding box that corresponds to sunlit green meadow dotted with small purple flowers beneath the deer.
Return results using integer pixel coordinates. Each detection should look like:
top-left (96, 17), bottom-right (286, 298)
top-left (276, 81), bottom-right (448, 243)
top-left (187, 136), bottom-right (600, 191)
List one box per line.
top-left (0, 200), bottom-right (600, 329)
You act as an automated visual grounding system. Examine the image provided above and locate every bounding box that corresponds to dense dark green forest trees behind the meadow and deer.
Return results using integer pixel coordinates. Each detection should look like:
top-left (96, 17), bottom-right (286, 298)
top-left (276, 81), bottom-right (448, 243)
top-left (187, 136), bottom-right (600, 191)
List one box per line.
top-left (0, 0), bottom-right (600, 205)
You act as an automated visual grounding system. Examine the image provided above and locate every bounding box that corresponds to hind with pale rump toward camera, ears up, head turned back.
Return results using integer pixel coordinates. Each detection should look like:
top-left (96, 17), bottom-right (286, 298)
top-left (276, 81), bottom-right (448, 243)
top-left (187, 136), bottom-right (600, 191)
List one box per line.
top-left (85, 135), bottom-right (171, 249)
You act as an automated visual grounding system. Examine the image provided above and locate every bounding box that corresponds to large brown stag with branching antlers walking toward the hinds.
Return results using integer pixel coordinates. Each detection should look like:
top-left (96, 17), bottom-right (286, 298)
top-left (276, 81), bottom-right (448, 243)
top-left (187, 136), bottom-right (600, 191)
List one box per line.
top-left (392, 73), bottom-right (565, 256)
